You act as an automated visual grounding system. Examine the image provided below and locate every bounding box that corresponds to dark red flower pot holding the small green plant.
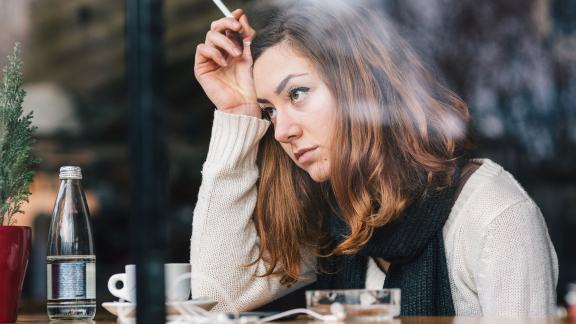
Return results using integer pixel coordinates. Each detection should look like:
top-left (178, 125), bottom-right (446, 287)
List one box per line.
top-left (0, 226), bottom-right (32, 323)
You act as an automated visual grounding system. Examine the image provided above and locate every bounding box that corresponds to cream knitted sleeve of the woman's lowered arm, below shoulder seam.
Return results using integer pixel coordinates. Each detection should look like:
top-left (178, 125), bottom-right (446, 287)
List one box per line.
top-left (476, 199), bottom-right (558, 317)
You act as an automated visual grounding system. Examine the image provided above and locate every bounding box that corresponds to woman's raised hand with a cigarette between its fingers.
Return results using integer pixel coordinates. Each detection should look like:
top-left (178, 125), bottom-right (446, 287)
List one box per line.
top-left (194, 9), bottom-right (261, 117)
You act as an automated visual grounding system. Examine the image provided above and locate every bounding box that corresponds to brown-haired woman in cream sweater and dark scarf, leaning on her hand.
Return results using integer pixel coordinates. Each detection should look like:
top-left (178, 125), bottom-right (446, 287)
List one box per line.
top-left (191, 1), bottom-right (558, 316)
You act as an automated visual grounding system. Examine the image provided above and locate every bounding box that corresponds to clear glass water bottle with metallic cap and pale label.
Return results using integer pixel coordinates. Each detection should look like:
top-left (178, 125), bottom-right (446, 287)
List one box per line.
top-left (47, 166), bottom-right (96, 320)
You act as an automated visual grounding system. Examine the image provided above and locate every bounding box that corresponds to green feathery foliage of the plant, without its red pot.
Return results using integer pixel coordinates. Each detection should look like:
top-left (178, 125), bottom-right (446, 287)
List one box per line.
top-left (0, 44), bottom-right (39, 225)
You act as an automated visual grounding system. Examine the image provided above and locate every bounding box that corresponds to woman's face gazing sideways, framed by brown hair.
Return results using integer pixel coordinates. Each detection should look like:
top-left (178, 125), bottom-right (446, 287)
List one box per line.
top-left (254, 43), bottom-right (336, 182)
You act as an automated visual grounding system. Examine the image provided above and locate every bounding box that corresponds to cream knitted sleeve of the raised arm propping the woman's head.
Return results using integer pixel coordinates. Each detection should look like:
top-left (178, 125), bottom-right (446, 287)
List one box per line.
top-left (190, 111), bottom-right (315, 311)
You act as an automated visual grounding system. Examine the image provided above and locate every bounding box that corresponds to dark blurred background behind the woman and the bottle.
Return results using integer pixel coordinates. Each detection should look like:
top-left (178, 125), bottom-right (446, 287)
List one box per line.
top-left (0, 0), bottom-right (576, 316)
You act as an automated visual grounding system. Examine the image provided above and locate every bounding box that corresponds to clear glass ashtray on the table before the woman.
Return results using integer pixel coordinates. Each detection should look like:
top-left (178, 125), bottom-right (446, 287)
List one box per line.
top-left (306, 288), bottom-right (400, 321)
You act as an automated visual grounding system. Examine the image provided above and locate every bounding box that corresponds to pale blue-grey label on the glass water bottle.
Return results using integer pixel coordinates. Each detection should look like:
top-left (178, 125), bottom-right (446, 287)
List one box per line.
top-left (47, 261), bottom-right (96, 300)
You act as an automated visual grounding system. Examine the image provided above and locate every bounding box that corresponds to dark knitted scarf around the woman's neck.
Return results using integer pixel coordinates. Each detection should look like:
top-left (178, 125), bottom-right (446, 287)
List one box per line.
top-left (316, 172), bottom-right (459, 316)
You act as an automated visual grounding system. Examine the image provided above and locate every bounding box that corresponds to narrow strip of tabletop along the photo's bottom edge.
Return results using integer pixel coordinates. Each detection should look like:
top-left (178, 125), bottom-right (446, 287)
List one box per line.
top-left (16, 314), bottom-right (570, 324)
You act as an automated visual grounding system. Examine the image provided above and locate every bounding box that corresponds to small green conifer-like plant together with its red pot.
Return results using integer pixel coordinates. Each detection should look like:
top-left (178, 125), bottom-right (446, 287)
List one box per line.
top-left (0, 44), bottom-right (38, 323)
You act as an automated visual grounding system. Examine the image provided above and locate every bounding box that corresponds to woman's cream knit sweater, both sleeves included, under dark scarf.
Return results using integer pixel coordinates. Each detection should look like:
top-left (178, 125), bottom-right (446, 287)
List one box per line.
top-left (190, 111), bottom-right (558, 317)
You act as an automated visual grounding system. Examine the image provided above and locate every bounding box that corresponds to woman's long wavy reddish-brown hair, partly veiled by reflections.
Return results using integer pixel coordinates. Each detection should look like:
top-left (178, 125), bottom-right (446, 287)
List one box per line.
top-left (252, 0), bottom-right (473, 285)
